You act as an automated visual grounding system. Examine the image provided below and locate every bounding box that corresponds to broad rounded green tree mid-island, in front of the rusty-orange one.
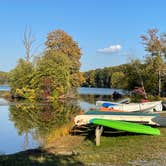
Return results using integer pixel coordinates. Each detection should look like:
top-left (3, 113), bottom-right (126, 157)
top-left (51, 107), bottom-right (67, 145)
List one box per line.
top-left (31, 50), bottom-right (71, 98)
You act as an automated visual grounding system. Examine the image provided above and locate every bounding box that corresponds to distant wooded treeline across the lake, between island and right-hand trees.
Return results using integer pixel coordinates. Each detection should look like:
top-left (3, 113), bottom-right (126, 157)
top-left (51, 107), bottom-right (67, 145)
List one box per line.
top-left (83, 64), bottom-right (142, 89)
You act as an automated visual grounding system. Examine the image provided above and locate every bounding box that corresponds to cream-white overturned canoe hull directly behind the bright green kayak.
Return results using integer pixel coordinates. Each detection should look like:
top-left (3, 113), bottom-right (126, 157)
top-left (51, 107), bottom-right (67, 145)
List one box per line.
top-left (74, 114), bottom-right (158, 126)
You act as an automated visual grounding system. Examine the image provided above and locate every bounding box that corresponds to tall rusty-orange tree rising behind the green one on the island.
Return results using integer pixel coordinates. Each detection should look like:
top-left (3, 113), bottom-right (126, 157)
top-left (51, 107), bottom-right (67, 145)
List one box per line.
top-left (45, 30), bottom-right (82, 87)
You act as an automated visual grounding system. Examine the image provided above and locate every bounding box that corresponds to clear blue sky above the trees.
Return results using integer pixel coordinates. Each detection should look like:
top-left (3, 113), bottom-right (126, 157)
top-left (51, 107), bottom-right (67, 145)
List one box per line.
top-left (0, 0), bottom-right (166, 71)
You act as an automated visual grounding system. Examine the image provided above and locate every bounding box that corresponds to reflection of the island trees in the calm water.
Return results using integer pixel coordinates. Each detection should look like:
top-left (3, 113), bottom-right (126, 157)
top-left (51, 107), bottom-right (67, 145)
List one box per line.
top-left (10, 101), bottom-right (81, 149)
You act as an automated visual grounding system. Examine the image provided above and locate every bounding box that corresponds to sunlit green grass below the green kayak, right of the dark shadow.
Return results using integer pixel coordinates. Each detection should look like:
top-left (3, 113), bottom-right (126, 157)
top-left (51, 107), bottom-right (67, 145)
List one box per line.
top-left (75, 129), bottom-right (166, 165)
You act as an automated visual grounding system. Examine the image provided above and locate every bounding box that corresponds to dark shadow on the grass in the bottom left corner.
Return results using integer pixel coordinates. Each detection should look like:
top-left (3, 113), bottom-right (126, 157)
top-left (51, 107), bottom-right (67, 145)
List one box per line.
top-left (0, 149), bottom-right (84, 166)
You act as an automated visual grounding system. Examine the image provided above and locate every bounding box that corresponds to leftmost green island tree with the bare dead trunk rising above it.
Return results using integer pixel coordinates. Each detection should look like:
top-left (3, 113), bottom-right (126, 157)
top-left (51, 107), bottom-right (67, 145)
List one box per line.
top-left (9, 27), bottom-right (35, 99)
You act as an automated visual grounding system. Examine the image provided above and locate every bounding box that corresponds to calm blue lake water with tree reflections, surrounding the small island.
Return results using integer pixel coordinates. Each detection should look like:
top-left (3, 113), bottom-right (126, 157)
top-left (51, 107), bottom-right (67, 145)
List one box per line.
top-left (0, 86), bottom-right (121, 154)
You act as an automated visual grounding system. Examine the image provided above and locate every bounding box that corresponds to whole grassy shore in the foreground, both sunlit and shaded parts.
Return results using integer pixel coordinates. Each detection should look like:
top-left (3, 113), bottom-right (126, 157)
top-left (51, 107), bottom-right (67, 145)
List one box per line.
top-left (0, 128), bottom-right (166, 166)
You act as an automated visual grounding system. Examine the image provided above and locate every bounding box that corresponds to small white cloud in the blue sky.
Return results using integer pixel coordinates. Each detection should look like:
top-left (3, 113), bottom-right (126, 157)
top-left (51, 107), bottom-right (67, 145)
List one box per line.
top-left (97, 44), bottom-right (122, 54)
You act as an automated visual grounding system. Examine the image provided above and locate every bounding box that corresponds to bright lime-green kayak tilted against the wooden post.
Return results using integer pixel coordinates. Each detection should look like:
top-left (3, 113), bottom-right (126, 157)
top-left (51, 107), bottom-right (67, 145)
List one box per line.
top-left (90, 118), bottom-right (160, 135)
